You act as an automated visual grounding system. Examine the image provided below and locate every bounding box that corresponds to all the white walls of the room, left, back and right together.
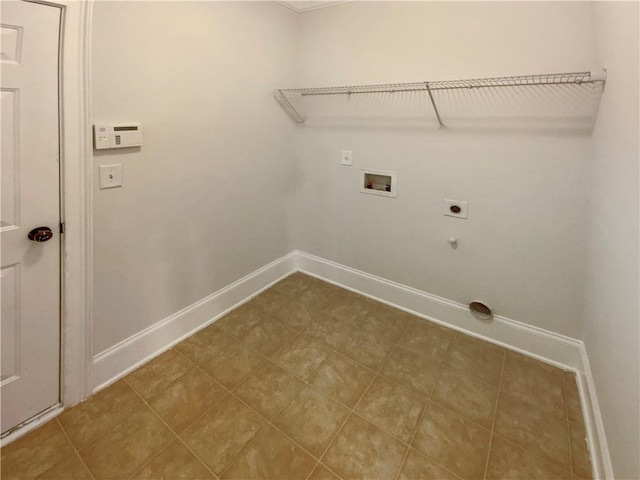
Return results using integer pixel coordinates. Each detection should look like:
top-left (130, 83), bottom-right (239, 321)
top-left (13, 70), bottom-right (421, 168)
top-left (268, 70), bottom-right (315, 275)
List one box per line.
top-left (86, 2), bottom-right (640, 472)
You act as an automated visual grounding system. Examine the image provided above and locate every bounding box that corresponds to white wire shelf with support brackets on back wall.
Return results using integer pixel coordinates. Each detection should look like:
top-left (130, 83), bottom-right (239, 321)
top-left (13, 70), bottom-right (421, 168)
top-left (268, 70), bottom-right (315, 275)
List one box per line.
top-left (275, 69), bottom-right (606, 128)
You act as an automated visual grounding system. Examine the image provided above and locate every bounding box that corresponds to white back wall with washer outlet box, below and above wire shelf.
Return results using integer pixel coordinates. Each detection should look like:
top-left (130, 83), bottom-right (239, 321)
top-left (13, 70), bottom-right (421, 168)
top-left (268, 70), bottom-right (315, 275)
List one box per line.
top-left (296, 2), bottom-right (593, 337)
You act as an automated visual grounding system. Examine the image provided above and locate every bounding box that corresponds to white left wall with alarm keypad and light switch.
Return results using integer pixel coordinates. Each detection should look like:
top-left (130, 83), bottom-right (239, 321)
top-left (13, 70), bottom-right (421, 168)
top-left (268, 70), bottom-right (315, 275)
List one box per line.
top-left (92, 1), bottom-right (297, 354)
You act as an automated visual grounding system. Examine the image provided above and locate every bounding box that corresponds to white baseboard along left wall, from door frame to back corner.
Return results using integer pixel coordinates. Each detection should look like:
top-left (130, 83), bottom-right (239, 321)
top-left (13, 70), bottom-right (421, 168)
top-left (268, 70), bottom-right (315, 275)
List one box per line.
top-left (92, 252), bottom-right (296, 393)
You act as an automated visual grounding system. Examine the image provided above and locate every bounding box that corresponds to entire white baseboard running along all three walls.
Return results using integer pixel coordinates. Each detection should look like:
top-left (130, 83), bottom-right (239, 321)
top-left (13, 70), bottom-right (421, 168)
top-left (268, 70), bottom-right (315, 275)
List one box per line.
top-left (87, 251), bottom-right (613, 479)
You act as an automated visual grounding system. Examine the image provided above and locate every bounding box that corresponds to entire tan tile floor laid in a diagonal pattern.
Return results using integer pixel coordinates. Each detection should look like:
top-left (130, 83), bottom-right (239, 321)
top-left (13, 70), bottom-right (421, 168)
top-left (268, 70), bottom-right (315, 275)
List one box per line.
top-left (1, 274), bottom-right (591, 480)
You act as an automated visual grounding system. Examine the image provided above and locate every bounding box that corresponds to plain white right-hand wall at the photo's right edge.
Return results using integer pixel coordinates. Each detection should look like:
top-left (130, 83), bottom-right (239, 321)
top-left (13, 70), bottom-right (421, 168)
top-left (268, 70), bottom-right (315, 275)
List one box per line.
top-left (584, 2), bottom-right (640, 479)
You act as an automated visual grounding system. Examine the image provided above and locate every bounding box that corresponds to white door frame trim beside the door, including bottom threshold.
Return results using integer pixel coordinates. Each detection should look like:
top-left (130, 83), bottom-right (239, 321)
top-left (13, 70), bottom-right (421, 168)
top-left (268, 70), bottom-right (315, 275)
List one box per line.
top-left (0, 0), bottom-right (93, 446)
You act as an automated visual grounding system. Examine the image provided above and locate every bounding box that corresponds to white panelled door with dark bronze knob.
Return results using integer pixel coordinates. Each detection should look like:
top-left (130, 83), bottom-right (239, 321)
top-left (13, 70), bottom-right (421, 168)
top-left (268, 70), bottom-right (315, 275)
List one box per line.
top-left (0, 0), bottom-right (60, 433)
